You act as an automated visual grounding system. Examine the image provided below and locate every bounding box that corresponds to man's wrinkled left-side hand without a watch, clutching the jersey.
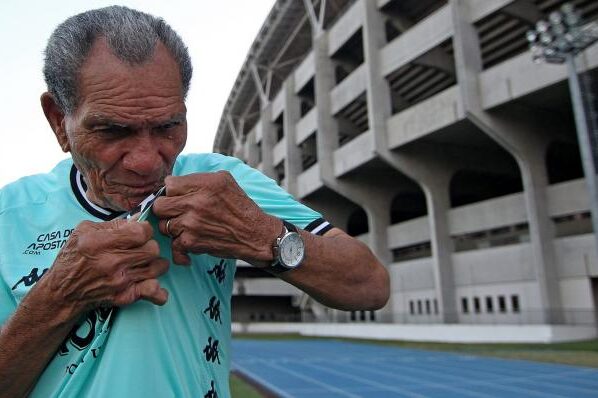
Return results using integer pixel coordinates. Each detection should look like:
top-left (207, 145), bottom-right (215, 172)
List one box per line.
top-left (40, 216), bottom-right (168, 312)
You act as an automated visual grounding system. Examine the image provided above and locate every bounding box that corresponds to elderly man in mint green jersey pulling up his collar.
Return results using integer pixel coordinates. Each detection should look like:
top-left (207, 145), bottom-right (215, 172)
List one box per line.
top-left (0, 7), bottom-right (389, 397)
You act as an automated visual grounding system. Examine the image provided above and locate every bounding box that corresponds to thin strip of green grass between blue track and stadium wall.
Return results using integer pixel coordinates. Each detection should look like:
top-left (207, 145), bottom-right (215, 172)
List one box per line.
top-left (235, 334), bottom-right (598, 368)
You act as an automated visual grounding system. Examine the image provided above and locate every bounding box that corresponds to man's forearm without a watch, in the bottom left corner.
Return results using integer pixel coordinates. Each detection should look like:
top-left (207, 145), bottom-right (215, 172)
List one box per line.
top-left (0, 279), bottom-right (77, 398)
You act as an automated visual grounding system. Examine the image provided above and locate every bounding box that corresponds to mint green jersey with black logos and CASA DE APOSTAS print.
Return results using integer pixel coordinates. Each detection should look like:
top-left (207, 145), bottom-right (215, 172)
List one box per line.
top-left (0, 154), bottom-right (330, 398)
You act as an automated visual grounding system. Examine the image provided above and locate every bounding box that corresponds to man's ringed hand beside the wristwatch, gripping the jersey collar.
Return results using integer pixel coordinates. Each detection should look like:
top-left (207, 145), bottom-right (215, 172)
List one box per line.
top-left (153, 171), bottom-right (282, 265)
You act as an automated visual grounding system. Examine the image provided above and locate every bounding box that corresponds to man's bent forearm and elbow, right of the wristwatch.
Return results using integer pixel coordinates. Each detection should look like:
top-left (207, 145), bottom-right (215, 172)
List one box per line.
top-left (280, 229), bottom-right (390, 310)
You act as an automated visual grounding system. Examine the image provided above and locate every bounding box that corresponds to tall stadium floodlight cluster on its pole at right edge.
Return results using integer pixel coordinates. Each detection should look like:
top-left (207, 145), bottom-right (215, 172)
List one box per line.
top-left (525, 3), bottom-right (598, 250)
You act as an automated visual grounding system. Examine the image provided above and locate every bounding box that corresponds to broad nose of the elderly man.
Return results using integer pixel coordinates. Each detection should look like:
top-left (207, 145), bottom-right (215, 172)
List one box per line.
top-left (123, 132), bottom-right (162, 176)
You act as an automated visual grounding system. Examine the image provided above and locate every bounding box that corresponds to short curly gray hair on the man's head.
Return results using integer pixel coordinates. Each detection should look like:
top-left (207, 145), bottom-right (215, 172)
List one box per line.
top-left (43, 6), bottom-right (193, 114)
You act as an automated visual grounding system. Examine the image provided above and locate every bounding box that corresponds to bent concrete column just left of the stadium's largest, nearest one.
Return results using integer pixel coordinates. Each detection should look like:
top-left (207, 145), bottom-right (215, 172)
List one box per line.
top-left (360, 0), bottom-right (456, 323)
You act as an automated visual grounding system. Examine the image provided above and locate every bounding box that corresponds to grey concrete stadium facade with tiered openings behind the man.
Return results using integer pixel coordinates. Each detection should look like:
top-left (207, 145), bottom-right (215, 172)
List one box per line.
top-left (214, 0), bottom-right (598, 327)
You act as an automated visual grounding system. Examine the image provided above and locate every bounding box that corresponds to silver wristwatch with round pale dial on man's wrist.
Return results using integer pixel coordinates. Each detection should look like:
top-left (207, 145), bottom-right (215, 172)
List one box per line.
top-left (269, 220), bottom-right (305, 274)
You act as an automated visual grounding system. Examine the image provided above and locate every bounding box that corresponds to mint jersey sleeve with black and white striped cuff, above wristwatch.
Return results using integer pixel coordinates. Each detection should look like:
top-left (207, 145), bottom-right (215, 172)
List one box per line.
top-left (229, 160), bottom-right (332, 235)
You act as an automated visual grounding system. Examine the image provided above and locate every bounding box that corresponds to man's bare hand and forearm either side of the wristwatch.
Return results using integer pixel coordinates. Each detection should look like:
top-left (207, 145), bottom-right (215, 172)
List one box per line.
top-left (152, 171), bottom-right (390, 311)
